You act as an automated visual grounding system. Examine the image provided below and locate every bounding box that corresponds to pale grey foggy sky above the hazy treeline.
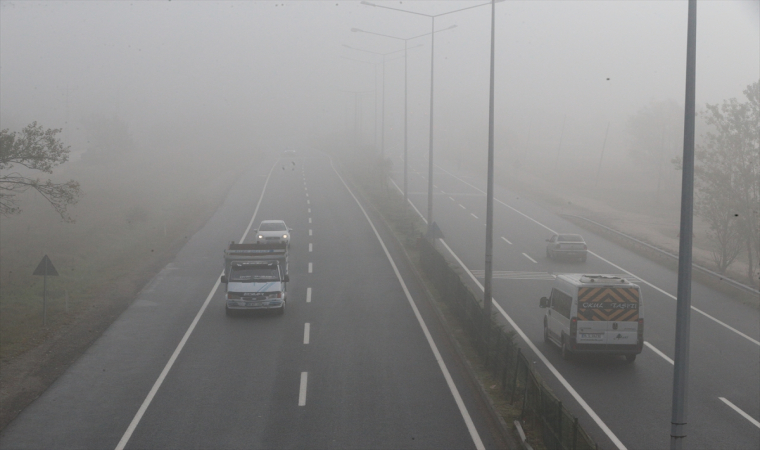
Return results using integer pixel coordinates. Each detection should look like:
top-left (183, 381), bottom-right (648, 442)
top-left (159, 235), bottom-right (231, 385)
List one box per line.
top-left (0, 0), bottom-right (760, 165)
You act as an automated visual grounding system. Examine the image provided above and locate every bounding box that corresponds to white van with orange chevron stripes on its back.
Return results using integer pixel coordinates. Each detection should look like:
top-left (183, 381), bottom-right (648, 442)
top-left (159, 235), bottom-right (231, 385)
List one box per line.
top-left (540, 273), bottom-right (644, 362)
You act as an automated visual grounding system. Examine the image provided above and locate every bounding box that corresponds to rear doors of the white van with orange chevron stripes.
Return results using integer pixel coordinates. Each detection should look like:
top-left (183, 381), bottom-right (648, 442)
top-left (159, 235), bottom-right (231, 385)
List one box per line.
top-left (576, 286), bottom-right (639, 345)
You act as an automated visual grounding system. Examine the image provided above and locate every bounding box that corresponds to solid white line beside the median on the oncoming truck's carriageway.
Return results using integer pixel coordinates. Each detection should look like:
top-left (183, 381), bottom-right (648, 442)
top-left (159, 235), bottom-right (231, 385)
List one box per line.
top-left (330, 159), bottom-right (485, 450)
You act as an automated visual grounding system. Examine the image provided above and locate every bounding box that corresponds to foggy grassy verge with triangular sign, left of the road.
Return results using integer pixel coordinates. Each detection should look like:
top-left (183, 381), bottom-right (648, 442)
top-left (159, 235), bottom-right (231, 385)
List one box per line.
top-left (0, 154), bottom-right (242, 429)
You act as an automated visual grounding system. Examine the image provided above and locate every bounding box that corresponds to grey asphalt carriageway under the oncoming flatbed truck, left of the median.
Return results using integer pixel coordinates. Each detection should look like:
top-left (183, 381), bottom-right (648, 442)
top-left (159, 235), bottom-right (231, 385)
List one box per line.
top-left (0, 151), bottom-right (505, 449)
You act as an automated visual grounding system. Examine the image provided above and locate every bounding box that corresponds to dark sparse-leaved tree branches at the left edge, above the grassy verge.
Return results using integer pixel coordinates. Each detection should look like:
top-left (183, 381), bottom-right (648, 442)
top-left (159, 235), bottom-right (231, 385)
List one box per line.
top-left (0, 122), bottom-right (81, 222)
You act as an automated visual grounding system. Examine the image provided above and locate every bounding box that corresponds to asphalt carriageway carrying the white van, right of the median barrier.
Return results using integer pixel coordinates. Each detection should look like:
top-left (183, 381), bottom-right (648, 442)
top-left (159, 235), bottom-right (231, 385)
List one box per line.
top-left (393, 152), bottom-right (760, 450)
